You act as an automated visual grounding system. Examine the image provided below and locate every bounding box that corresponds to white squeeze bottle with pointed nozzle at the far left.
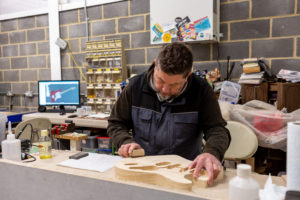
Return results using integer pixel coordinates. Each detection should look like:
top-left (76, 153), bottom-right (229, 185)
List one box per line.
top-left (1, 122), bottom-right (21, 162)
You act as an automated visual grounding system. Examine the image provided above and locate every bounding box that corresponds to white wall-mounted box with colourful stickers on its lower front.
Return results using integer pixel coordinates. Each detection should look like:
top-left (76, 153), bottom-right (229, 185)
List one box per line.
top-left (150, 0), bottom-right (219, 44)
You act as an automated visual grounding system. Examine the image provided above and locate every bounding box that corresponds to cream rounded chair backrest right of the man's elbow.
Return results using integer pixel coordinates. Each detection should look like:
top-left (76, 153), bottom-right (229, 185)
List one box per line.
top-left (224, 121), bottom-right (258, 160)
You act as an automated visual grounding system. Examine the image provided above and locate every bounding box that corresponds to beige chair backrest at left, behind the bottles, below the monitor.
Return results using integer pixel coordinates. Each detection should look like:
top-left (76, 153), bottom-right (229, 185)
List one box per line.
top-left (15, 118), bottom-right (51, 142)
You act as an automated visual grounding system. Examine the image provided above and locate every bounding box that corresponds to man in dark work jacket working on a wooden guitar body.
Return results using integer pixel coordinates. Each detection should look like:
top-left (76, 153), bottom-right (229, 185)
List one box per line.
top-left (107, 43), bottom-right (230, 184)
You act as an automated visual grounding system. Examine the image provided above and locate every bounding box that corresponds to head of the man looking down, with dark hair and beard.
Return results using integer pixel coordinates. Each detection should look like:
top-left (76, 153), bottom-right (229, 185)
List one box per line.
top-left (153, 42), bottom-right (193, 99)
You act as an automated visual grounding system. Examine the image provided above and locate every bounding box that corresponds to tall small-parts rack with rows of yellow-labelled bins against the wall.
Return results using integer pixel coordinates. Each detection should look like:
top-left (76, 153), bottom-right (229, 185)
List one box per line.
top-left (86, 39), bottom-right (127, 112)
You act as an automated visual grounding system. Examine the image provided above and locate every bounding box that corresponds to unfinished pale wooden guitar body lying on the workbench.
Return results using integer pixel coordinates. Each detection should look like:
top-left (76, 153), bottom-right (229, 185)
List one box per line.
top-left (115, 155), bottom-right (223, 190)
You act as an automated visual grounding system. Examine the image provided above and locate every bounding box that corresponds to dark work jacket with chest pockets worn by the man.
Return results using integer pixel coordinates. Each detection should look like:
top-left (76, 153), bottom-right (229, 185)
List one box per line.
top-left (107, 66), bottom-right (230, 160)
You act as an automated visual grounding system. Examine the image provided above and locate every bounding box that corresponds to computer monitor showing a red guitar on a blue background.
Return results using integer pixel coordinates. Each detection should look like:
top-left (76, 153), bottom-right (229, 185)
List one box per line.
top-left (38, 80), bottom-right (80, 106)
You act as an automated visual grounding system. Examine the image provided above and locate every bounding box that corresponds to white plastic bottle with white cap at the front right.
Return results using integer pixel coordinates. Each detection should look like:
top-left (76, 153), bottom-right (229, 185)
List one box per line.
top-left (229, 164), bottom-right (259, 200)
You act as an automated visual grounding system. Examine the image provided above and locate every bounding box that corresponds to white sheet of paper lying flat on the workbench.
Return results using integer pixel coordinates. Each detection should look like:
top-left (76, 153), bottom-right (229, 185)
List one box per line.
top-left (58, 153), bottom-right (123, 172)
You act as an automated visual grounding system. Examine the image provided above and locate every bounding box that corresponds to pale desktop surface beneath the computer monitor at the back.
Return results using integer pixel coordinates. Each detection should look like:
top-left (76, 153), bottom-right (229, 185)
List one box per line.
top-left (22, 113), bottom-right (108, 129)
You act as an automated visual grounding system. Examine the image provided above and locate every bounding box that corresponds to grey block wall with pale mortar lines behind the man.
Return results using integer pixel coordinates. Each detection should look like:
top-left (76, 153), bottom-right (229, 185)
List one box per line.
top-left (0, 0), bottom-right (300, 109)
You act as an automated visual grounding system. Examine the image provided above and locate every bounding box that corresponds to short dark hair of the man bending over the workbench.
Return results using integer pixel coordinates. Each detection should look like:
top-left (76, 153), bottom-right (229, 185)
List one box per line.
top-left (157, 42), bottom-right (193, 77)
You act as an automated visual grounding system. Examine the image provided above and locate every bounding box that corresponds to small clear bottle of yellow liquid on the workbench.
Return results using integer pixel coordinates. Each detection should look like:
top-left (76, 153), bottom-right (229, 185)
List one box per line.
top-left (39, 130), bottom-right (52, 159)
